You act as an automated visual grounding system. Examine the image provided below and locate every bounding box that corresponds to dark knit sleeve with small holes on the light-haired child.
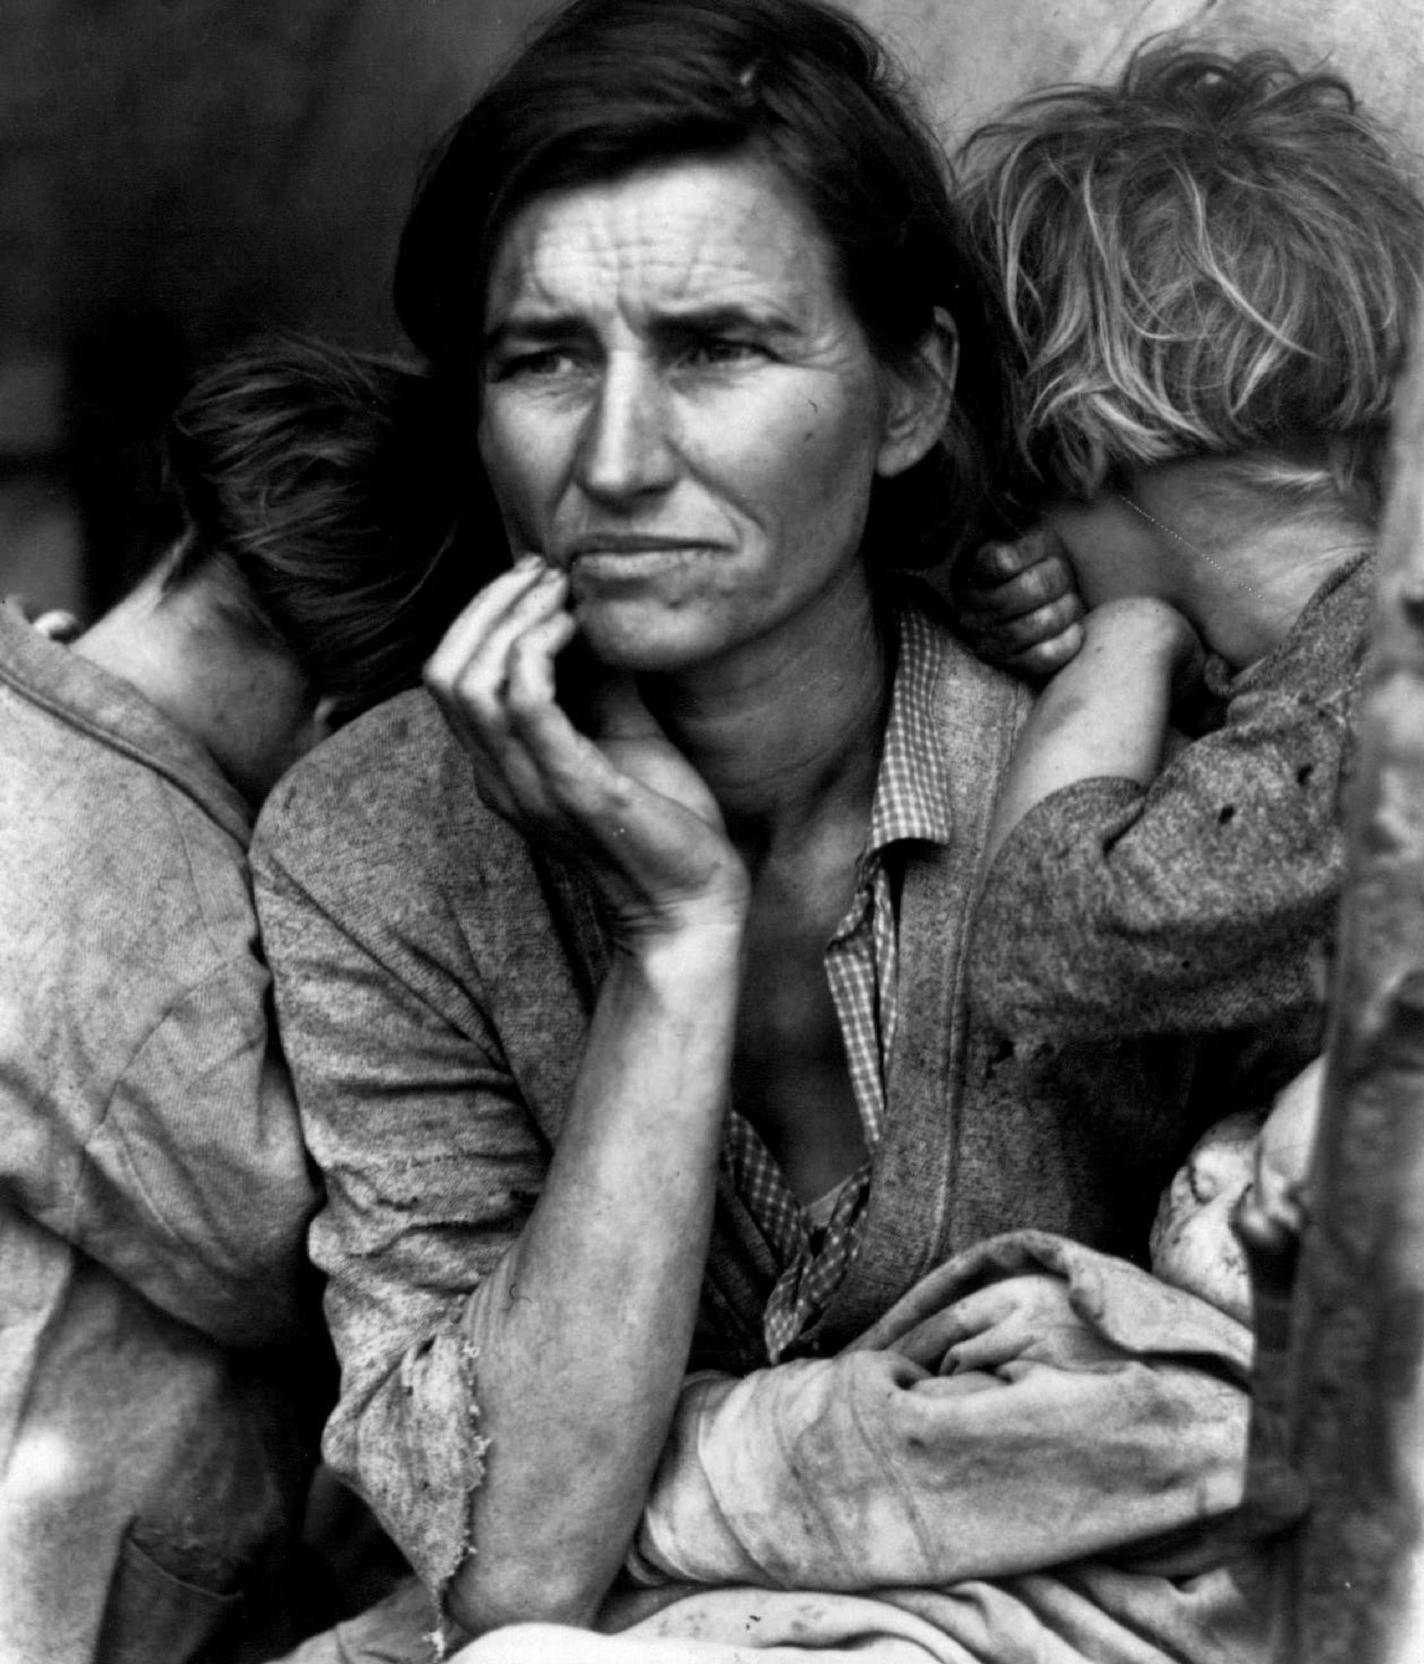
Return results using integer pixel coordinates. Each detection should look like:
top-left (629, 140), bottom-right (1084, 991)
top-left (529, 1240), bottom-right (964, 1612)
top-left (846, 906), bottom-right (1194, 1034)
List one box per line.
top-left (970, 557), bottom-right (1374, 1038)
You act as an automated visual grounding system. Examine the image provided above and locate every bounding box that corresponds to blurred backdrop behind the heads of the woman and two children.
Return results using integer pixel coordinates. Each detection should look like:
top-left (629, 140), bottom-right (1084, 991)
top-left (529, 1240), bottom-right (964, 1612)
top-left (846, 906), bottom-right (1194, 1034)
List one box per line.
top-left (0, 0), bottom-right (1424, 616)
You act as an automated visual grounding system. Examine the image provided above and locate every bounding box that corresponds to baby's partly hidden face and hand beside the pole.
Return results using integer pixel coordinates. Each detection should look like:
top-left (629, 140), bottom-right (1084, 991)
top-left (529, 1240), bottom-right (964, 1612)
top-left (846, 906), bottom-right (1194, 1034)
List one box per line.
top-left (1151, 1058), bottom-right (1323, 1323)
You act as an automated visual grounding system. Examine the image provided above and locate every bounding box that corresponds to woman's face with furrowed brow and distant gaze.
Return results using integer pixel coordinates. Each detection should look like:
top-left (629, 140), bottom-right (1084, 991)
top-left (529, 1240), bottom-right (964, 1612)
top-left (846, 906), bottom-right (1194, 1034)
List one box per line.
top-left (479, 158), bottom-right (937, 671)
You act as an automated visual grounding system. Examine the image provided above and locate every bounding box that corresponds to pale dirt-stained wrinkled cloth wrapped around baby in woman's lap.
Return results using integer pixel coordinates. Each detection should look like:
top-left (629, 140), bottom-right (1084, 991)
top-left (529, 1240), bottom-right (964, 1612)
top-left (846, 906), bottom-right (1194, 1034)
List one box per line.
top-left (632, 1231), bottom-right (1251, 1591)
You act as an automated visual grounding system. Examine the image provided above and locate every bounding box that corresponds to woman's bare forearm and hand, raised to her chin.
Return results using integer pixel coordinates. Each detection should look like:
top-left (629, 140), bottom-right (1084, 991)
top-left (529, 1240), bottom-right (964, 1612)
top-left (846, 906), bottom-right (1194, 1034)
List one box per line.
top-left (426, 557), bottom-right (749, 1632)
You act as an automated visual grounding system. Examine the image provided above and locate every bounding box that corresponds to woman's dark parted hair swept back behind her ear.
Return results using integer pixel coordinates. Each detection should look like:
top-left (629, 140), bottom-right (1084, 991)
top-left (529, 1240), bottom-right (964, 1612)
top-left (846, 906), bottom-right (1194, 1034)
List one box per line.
top-left (396, 0), bottom-right (1003, 566)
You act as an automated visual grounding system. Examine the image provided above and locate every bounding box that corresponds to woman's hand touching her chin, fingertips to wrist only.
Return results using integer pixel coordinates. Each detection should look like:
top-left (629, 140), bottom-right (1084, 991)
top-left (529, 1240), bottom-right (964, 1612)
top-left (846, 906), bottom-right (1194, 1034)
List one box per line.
top-left (426, 556), bottom-right (747, 943)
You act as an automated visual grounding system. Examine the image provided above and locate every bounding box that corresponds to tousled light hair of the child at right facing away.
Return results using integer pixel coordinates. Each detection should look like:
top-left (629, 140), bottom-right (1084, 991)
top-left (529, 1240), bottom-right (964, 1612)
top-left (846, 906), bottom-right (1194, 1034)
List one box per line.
top-left (962, 42), bottom-right (1424, 512)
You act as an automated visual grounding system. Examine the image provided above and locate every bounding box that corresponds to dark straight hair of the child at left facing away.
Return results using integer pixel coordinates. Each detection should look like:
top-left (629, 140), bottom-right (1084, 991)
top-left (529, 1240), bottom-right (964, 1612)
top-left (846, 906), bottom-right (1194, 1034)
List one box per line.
top-left (165, 341), bottom-right (502, 719)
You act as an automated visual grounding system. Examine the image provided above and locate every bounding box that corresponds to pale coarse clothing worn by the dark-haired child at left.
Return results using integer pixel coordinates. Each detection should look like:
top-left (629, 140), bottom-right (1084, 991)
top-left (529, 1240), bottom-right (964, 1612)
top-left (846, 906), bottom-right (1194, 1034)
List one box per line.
top-left (0, 611), bottom-right (329, 1664)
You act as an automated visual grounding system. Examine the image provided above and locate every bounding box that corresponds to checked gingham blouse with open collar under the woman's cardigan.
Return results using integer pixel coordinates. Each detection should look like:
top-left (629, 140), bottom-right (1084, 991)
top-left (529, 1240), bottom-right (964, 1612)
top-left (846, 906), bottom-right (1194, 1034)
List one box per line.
top-left (722, 611), bottom-right (950, 1363)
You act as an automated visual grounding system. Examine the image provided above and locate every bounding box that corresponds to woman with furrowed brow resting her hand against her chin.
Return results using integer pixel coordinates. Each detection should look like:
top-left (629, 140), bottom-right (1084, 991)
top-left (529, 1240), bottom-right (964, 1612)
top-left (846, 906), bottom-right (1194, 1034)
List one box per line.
top-left (255, 0), bottom-right (1304, 1657)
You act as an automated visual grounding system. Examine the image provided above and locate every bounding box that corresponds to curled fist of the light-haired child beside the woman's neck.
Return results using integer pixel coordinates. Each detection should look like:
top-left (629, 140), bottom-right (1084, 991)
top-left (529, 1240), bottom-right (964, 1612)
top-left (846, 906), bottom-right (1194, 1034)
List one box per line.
top-left (952, 526), bottom-right (1083, 677)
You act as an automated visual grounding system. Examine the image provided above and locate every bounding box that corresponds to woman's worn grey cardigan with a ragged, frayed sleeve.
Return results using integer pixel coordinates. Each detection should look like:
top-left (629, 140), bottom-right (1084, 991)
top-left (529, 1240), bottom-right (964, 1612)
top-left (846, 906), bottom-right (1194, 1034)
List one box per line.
top-left (253, 595), bottom-right (1290, 1591)
